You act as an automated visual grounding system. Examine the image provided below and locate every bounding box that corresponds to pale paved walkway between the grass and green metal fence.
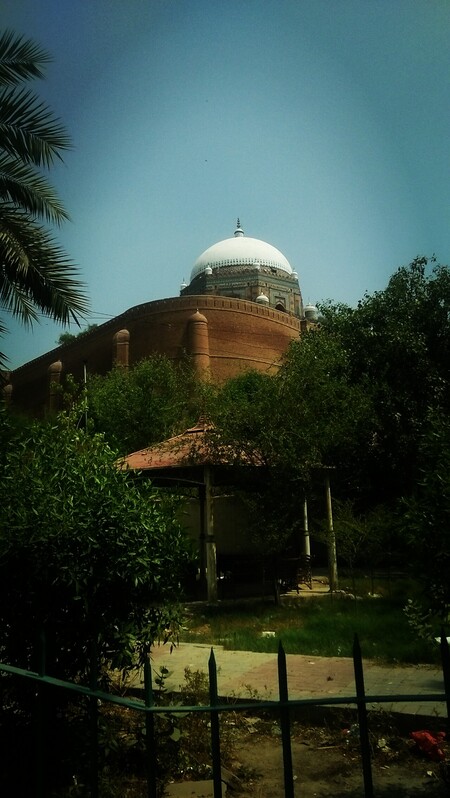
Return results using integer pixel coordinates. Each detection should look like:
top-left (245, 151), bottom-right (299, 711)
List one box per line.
top-left (151, 643), bottom-right (447, 721)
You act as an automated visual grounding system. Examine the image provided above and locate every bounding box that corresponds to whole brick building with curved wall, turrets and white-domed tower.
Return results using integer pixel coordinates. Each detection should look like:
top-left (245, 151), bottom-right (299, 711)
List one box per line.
top-left (5, 220), bottom-right (315, 415)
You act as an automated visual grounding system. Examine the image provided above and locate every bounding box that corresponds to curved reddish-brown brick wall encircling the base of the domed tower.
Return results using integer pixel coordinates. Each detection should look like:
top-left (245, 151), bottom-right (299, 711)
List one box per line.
top-left (10, 295), bottom-right (300, 415)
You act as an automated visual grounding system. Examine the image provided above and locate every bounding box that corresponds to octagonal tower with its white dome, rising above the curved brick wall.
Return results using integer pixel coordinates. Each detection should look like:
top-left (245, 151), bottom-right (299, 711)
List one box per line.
top-left (180, 219), bottom-right (304, 318)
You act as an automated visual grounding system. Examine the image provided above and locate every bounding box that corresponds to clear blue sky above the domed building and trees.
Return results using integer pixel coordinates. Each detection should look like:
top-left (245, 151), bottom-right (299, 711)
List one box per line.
top-left (0, 0), bottom-right (450, 368)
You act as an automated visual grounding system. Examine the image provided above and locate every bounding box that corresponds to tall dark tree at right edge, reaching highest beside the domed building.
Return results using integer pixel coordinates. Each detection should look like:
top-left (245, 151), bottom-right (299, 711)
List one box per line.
top-left (321, 258), bottom-right (450, 505)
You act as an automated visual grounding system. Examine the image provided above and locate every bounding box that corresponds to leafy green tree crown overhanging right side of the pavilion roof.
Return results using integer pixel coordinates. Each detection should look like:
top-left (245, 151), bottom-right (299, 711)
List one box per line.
top-left (208, 330), bottom-right (371, 480)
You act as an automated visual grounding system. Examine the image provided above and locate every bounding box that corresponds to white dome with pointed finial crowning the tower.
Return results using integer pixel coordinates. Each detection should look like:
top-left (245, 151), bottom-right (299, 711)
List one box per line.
top-left (191, 221), bottom-right (292, 281)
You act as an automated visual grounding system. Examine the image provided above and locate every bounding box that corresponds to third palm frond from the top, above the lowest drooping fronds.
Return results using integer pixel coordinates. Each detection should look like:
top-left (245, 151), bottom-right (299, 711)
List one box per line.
top-left (0, 155), bottom-right (70, 224)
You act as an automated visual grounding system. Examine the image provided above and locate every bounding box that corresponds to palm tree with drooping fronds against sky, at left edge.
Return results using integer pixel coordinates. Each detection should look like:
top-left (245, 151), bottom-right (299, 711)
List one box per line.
top-left (0, 31), bottom-right (87, 366)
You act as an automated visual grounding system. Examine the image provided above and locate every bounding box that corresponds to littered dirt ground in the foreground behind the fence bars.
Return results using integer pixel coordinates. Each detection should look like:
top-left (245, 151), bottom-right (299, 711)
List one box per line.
top-left (82, 684), bottom-right (450, 798)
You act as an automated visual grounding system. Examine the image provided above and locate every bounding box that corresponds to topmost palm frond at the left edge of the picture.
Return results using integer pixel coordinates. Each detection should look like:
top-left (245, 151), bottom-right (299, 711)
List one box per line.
top-left (0, 31), bottom-right (52, 86)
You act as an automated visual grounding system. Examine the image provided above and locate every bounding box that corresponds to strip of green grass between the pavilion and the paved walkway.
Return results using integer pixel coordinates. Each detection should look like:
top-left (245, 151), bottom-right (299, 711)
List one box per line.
top-left (181, 596), bottom-right (439, 664)
